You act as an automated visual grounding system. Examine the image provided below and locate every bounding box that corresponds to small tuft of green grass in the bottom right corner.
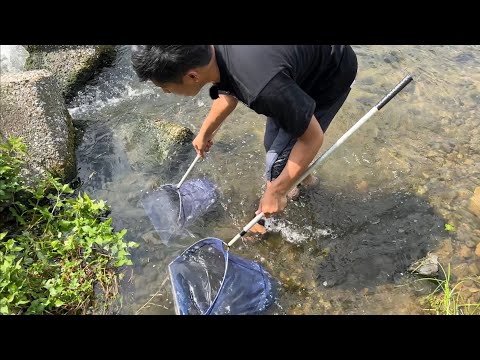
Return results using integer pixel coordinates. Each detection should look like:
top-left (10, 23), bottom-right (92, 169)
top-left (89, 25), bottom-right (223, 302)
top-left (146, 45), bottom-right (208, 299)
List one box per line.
top-left (419, 263), bottom-right (480, 315)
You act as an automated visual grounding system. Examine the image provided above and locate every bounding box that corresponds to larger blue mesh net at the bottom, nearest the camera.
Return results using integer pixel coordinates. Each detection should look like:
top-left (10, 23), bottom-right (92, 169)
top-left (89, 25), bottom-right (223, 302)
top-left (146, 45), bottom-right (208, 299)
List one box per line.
top-left (168, 238), bottom-right (275, 315)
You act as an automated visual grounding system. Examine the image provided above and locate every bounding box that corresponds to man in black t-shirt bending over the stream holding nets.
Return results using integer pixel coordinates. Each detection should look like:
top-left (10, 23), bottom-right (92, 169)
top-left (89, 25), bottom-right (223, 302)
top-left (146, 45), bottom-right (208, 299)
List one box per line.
top-left (132, 45), bottom-right (357, 222)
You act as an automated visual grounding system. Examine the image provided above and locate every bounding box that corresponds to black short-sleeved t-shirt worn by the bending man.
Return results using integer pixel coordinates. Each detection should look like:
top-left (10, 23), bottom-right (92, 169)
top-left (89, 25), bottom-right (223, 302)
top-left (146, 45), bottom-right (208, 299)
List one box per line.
top-left (210, 45), bottom-right (357, 137)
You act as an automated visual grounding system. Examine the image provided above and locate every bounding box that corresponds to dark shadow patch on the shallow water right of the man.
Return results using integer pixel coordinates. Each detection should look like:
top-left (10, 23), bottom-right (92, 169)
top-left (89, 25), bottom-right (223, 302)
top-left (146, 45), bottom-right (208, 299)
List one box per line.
top-left (306, 187), bottom-right (445, 289)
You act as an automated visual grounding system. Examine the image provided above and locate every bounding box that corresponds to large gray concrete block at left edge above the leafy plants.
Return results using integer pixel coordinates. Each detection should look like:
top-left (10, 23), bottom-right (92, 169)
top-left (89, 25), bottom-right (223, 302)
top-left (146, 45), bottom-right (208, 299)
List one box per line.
top-left (0, 70), bottom-right (76, 181)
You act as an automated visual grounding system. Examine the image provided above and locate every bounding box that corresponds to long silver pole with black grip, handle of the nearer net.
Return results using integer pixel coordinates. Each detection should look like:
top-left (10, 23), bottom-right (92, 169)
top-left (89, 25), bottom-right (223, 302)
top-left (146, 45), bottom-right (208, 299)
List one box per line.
top-left (228, 75), bottom-right (413, 247)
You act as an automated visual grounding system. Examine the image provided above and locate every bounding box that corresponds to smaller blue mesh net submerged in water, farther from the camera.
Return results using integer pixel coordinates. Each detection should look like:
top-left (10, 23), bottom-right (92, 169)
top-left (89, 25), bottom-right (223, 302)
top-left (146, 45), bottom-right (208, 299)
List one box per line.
top-left (142, 179), bottom-right (217, 243)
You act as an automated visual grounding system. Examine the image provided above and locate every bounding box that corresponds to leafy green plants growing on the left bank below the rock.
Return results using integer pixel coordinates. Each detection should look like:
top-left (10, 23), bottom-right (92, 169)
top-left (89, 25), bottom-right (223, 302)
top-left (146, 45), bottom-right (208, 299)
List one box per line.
top-left (0, 138), bottom-right (137, 314)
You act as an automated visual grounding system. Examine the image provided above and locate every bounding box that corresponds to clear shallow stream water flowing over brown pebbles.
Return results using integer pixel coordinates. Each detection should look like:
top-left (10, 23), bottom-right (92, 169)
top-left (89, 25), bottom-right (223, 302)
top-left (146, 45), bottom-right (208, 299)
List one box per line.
top-left (69, 45), bottom-right (480, 314)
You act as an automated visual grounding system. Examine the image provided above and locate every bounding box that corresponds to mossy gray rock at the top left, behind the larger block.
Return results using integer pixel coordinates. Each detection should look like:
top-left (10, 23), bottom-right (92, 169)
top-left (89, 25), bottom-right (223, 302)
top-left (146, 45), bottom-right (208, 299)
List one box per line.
top-left (24, 45), bottom-right (116, 102)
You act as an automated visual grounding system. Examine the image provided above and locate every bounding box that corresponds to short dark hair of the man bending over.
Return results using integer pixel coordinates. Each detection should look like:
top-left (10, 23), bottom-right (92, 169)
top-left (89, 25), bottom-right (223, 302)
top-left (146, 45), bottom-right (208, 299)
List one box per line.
top-left (132, 45), bottom-right (212, 83)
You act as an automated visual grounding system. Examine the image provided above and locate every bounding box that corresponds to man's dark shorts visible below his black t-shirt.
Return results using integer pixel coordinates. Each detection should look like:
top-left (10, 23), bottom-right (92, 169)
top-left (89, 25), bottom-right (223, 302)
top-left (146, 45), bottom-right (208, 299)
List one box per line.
top-left (263, 88), bottom-right (351, 181)
